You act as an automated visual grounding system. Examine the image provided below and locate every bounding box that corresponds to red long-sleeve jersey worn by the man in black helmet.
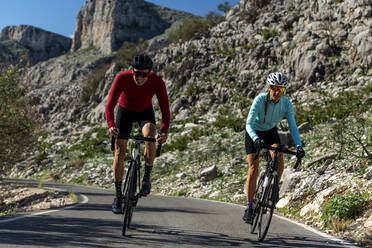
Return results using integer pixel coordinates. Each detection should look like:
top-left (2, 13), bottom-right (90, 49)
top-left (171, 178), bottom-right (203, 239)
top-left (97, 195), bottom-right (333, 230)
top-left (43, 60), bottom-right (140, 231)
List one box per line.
top-left (105, 70), bottom-right (170, 133)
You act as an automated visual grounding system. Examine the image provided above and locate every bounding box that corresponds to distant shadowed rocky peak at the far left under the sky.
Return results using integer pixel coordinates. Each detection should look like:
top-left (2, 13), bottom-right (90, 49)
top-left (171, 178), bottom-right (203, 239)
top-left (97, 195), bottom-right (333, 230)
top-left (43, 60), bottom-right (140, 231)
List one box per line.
top-left (0, 25), bottom-right (71, 64)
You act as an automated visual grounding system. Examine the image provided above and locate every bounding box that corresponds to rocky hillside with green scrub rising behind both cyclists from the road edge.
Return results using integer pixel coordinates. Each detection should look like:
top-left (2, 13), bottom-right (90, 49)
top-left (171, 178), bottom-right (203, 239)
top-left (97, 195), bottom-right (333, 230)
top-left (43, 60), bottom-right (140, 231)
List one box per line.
top-left (3, 0), bottom-right (372, 246)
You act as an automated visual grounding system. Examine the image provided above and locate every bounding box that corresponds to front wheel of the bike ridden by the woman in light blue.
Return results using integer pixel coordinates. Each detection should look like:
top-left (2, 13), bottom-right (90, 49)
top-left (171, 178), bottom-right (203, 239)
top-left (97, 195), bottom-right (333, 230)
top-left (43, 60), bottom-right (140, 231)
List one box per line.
top-left (257, 175), bottom-right (278, 241)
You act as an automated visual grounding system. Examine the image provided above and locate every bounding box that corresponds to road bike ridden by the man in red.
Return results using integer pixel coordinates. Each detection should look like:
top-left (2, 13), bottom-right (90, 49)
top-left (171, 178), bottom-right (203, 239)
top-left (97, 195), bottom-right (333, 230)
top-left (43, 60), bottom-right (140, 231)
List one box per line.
top-left (121, 132), bottom-right (161, 236)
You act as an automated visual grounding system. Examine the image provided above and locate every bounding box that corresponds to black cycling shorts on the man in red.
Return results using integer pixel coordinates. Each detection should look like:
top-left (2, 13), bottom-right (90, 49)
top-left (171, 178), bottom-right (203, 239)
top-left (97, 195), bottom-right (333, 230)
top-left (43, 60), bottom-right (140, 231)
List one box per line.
top-left (115, 105), bottom-right (156, 139)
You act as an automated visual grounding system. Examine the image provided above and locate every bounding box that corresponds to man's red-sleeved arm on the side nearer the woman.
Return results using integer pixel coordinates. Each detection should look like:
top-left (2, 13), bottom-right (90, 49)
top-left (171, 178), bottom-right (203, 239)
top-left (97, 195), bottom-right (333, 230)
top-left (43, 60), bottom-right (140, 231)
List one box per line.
top-left (156, 78), bottom-right (170, 134)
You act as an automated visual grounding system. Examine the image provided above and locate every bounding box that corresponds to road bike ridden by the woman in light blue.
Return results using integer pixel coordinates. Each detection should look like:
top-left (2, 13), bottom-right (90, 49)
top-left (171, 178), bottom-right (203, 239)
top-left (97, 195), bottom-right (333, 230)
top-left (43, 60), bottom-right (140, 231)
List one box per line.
top-left (250, 145), bottom-right (301, 241)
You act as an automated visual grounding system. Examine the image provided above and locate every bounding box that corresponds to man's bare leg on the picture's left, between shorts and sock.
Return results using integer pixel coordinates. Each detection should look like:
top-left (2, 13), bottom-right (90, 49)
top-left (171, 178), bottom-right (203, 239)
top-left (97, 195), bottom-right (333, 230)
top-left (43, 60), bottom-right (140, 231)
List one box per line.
top-left (112, 139), bottom-right (128, 182)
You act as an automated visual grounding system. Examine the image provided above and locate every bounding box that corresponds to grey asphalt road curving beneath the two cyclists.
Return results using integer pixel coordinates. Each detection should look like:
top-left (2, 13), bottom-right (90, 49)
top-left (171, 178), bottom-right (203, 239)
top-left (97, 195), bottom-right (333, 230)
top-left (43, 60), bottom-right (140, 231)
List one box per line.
top-left (0, 179), bottom-right (355, 248)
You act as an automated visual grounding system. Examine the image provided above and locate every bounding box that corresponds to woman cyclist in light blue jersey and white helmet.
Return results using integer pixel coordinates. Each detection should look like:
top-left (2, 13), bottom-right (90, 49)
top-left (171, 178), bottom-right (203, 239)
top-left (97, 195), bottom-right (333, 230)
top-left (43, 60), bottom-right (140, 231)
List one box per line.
top-left (243, 72), bottom-right (305, 223)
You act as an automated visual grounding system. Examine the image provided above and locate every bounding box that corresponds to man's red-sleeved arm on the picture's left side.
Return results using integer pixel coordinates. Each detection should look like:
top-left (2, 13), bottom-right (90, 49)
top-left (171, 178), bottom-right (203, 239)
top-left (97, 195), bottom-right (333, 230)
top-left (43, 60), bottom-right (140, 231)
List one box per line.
top-left (105, 74), bottom-right (122, 128)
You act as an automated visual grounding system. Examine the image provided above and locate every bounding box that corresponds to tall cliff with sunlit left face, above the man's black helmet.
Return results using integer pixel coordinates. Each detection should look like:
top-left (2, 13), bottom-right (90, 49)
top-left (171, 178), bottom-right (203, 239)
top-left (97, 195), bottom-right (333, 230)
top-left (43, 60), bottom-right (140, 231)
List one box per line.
top-left (72, 0), bottom-right (192, 54)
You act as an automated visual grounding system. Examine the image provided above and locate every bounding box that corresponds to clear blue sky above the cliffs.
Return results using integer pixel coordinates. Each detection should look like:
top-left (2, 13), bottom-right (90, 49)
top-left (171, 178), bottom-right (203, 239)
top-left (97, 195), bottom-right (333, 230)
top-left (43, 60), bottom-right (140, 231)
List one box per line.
top-left (0, 0), bottom-right (239, 37)
